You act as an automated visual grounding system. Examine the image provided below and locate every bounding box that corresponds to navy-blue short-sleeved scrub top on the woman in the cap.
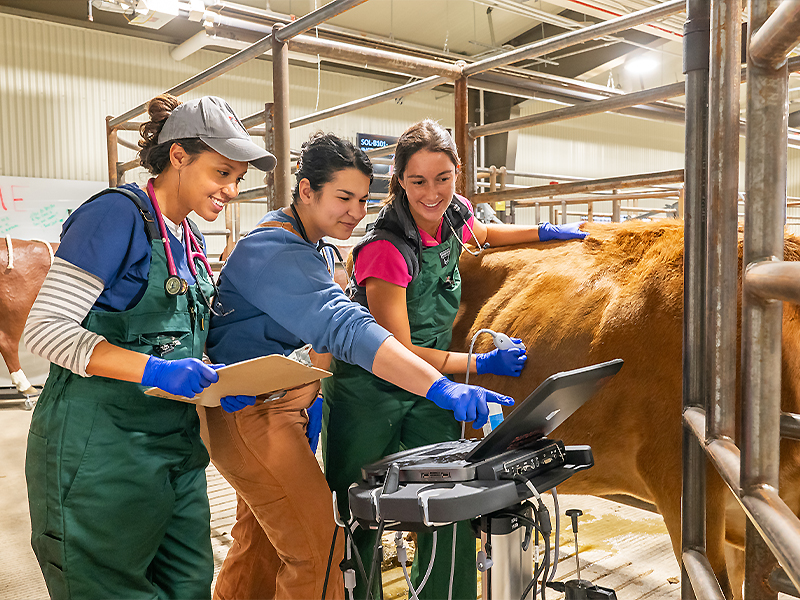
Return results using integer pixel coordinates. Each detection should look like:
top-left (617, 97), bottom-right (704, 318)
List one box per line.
top-left (55, 183), bottom-right (199, 311)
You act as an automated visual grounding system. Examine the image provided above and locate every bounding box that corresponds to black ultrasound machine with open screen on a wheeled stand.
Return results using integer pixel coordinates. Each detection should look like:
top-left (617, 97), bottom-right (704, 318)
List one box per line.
top-left (334, 359), bottom-right (622, 600)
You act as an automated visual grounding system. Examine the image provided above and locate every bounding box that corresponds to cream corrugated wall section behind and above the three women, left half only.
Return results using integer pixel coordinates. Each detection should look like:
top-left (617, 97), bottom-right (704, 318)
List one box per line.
top-left (0, 14), bottom-right (453, 180)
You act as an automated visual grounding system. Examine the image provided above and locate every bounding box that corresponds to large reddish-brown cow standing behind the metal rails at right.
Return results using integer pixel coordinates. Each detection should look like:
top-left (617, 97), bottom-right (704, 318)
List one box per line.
top-left (452, 220), bottom-right (800, 596)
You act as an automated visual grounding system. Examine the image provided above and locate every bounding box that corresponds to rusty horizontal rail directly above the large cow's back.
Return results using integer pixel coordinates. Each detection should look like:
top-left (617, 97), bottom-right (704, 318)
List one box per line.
top-left (474, 169), bottom-right (683, 202)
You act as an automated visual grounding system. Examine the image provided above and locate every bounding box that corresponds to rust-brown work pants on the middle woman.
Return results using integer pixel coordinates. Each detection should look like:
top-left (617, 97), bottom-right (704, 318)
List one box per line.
top-left (199, 382), bottom-right (344, 600)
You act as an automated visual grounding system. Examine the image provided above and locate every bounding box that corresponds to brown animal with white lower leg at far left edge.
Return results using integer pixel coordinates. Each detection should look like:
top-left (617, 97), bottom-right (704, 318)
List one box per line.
top-left (0, 237), bottom-right (58, 396)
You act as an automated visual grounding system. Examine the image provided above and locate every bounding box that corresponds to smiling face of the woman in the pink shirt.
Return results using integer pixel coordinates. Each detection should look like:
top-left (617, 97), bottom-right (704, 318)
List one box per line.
top-left (399, 150), bottom-right (457, 236)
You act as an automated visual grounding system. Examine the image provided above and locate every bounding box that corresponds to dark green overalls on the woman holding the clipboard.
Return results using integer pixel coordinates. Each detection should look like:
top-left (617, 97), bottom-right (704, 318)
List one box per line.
top-left (25, 239), bottom-right (214, 600)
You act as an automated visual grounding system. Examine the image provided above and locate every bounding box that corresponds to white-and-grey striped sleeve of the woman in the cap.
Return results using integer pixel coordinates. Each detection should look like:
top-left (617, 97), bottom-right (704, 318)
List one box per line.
top-left (25, 257), bottom-right (105, 377)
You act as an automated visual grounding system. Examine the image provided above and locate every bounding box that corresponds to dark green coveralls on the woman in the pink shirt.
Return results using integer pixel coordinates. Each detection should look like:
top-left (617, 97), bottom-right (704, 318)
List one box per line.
top-left (322, 235), bottom-right (477, 600)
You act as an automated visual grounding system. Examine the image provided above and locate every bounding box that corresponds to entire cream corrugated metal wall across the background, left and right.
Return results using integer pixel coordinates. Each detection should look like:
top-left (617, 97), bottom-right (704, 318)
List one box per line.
top-left (0, 9), bottom-right (800, 239)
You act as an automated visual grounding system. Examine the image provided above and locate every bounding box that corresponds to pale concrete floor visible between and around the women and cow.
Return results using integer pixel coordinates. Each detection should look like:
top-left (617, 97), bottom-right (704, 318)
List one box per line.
top-left (0, 403), bottom-right (680, 600)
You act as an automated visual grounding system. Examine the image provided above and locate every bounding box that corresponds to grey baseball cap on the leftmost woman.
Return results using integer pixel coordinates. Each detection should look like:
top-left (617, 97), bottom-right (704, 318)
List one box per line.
top-left (158, 96), bottom-right (278, 171)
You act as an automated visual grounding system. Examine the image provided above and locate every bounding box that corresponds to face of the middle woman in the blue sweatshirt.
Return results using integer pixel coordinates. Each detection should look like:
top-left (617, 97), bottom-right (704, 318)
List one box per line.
top-left (296, 167), bottom-right (369, 242)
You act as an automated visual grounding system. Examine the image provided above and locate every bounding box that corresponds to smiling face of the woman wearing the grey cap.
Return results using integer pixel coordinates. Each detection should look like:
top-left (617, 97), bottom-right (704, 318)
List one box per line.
top-left (173, 144), bottom-right (247, 221)
